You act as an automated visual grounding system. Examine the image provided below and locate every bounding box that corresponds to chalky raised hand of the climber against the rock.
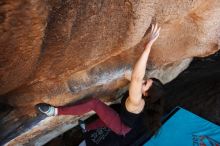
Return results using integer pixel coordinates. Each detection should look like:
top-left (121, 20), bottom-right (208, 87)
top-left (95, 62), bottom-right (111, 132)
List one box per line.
top-left (146, 24), bottom-right (160, 48)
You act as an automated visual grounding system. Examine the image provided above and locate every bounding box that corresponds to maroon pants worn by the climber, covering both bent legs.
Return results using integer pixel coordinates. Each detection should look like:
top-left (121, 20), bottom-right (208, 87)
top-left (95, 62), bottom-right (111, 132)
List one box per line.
top-left (58, 98), bottom-right (131, 135)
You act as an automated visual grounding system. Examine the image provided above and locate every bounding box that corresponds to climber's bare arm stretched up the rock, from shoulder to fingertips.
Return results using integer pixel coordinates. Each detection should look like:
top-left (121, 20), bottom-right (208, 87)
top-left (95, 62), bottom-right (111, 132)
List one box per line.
top-left (126, 24), bottom-right (160, 113)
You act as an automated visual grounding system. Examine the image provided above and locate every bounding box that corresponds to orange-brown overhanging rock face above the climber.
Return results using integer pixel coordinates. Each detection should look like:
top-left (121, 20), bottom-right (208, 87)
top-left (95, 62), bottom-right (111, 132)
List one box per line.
top-left (0, 0), bottom-right (220, 145)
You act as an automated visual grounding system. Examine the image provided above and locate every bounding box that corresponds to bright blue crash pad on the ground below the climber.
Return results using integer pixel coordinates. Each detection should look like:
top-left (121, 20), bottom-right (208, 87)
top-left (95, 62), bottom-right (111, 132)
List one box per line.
top-left (144, 108), bottom-right (220, 146)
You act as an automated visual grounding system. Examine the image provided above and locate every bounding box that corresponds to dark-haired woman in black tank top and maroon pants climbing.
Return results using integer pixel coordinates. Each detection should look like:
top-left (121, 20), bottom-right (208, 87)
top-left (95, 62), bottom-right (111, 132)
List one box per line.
top-left (36, 24), bottom-right (164, 146)
